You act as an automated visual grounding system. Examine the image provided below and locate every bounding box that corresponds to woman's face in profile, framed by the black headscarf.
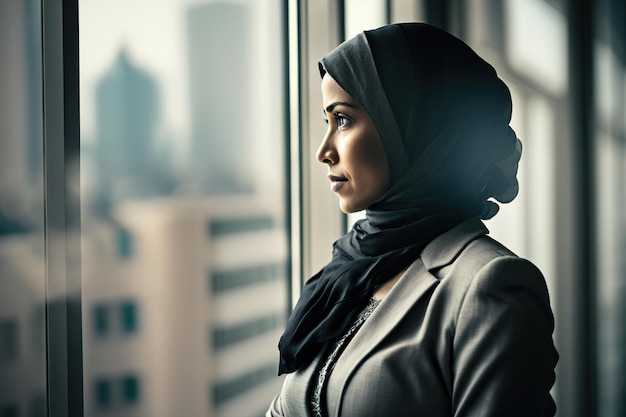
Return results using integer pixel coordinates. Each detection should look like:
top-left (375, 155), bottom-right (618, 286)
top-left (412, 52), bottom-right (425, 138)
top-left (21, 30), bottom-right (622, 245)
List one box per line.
top-left (317, 74), bottom-right (389, 213)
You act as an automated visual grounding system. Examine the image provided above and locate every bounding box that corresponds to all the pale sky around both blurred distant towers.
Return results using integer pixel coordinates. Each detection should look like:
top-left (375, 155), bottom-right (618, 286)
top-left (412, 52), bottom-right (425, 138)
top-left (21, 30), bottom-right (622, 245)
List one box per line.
top-left (79, 0), bottom-right (288, 194)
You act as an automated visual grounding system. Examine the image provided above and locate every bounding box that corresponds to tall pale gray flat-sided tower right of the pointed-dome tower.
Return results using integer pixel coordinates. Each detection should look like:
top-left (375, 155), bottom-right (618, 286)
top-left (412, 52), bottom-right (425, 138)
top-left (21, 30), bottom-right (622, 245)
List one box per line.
top-left (187, 2), bottom-right (254, 194)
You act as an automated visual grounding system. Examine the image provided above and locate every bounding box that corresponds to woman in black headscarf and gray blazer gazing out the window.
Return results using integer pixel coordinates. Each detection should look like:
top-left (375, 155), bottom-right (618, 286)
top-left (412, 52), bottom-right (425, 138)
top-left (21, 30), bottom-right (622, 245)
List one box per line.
top-left (267, 23), bottom-right (558, 417)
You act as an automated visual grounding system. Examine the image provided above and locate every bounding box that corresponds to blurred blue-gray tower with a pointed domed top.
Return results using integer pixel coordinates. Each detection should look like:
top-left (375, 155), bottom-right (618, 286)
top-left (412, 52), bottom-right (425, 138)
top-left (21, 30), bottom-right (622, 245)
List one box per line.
top-left (93, 50), bottom-right (168, 210)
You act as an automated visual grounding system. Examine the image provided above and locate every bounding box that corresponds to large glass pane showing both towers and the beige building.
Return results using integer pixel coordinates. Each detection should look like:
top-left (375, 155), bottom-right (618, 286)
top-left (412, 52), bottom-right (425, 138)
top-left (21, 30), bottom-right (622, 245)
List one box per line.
top-left (79, 0), bottom-right (289, 417)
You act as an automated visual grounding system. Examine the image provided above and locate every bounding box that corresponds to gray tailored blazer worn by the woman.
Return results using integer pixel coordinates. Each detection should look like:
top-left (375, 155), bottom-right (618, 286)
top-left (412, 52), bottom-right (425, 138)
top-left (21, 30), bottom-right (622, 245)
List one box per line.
top-left (266, 220), bottom-right (558, 417)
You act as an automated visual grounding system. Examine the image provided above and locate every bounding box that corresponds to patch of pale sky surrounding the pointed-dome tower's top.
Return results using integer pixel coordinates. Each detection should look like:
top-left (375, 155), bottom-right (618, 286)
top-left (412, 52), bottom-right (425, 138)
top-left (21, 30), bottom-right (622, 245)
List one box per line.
top-left (79, 0), bottom-right (190, 141)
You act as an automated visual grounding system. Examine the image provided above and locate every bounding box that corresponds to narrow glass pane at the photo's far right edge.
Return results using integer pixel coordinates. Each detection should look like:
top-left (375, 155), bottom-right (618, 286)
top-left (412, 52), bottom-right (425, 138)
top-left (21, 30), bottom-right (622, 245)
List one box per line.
top-left (593, 24), bottom-right (626, 417)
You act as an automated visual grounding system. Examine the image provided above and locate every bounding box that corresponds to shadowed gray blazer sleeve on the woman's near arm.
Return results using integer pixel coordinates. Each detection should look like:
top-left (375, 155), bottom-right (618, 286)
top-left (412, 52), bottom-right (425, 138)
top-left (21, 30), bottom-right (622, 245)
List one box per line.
top-left (452, 256), bottom-right (558, 417)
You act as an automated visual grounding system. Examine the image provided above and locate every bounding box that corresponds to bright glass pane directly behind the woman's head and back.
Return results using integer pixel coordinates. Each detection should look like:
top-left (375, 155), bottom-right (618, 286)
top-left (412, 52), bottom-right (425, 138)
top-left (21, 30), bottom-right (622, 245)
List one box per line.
top-left (466, 0), bottom-right (564, 404)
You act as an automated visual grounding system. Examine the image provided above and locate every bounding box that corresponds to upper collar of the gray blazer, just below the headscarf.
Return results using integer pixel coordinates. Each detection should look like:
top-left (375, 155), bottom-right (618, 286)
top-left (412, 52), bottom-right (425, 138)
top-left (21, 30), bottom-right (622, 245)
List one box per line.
top-left (420, 217), bottom-right (489, 271)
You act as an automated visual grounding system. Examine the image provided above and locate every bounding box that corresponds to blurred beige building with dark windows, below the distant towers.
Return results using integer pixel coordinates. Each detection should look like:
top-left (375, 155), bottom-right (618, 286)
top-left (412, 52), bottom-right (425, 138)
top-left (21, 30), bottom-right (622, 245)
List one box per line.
top-left (83, 197), bottom-right (288, 417)
